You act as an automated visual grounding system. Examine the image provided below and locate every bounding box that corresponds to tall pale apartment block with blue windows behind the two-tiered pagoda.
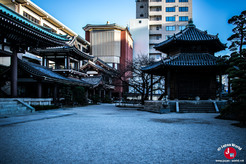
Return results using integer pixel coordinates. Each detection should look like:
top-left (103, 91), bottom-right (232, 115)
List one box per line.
top-left (130, 0), bottom-right (192, 60)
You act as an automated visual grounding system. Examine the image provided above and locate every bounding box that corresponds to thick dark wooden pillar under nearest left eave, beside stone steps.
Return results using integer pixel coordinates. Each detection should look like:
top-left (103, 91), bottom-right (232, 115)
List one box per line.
top-left (11, 49), bottom-right (18, 98)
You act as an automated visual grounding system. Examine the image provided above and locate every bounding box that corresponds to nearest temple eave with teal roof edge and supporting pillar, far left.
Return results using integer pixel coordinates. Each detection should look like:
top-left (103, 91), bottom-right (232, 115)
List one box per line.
top-left (0, 3), bottom-right (69, 97)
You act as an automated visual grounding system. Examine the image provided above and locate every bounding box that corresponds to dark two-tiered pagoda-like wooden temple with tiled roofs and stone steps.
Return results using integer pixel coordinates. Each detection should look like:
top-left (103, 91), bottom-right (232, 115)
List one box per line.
top-left (142, 21), bottom-right (227, 100)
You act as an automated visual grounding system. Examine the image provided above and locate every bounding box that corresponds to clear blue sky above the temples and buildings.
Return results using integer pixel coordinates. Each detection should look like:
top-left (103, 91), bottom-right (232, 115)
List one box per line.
top-left (32, 0), bottom-right (246, 54)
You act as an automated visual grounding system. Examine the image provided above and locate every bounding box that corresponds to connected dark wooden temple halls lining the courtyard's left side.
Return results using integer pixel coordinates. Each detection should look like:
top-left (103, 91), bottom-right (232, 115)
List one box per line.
top-left (0, 3), bottom-right (115, 107)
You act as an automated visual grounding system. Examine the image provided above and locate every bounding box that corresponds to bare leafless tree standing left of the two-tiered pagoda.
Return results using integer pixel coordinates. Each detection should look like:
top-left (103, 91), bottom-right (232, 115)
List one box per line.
top-left (118, 55), bottom-right (164, 104)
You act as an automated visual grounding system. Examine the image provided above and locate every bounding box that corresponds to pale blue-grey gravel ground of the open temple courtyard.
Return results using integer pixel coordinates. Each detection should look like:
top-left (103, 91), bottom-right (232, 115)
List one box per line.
top-left (0, 104), bottom-right (246, 164)
